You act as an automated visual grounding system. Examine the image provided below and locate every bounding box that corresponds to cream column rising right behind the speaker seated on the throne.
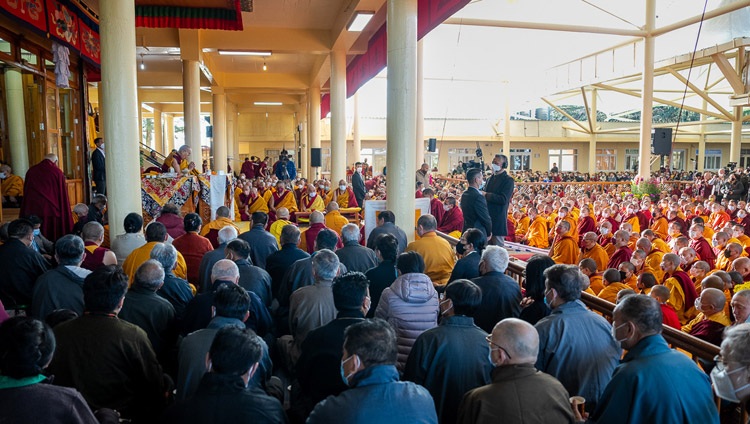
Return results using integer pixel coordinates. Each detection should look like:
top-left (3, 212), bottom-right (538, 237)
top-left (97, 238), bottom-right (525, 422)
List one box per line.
top-left (182, 59), bottom-right (202, 157)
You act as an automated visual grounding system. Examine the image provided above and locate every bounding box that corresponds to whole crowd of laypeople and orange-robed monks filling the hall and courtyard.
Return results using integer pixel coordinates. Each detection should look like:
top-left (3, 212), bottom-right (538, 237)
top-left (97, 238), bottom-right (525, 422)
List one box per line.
top-left (0, 150), bottom-right (750, 424)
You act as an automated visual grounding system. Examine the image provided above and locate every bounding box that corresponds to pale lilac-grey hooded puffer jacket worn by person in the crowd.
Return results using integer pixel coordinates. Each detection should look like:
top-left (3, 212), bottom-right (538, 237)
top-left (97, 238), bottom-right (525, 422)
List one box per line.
top-left (375, 273), bottom-right (439, 369)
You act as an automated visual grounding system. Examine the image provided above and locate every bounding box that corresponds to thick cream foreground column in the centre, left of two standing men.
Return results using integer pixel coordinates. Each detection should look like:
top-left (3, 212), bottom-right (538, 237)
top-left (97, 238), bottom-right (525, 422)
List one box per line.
top-left (386, 0), bottom-right (417, 240)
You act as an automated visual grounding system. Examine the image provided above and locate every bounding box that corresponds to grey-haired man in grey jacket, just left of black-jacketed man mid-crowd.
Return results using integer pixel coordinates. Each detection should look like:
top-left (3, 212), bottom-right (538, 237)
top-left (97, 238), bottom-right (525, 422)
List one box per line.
top-left (279, 249), bottom-right (339, 369)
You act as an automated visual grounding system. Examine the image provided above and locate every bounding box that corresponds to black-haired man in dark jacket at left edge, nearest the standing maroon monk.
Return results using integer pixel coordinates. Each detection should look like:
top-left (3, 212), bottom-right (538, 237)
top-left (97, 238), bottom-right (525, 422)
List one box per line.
top-left (0, 219), bottom-right (47, 309)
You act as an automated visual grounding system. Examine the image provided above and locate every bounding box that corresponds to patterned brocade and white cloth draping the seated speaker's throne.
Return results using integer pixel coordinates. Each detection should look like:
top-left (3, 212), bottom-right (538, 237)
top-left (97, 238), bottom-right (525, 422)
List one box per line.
top-left (141, 174), bottom-right (234, 223)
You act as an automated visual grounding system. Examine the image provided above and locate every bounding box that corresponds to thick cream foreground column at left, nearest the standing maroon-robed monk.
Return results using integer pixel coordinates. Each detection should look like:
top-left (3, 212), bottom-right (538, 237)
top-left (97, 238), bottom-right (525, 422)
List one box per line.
top-left (99, 0), bottom-right (142, 240)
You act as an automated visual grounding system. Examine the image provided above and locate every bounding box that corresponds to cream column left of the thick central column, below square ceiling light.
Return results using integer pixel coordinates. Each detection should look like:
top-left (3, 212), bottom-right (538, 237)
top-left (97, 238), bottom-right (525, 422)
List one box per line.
top-left (331, 50), bottom-right (346, 184)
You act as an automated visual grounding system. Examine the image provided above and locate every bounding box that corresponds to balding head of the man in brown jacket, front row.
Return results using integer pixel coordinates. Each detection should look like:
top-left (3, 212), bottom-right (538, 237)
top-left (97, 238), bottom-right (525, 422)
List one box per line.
top-left (490, 318), bottom-right (539, 364)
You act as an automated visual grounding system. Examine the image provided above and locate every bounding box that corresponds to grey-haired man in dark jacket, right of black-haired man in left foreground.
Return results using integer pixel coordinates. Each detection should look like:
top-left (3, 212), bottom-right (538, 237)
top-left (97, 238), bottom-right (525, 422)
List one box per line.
top-left (119, 259), bottom-right (177, 363)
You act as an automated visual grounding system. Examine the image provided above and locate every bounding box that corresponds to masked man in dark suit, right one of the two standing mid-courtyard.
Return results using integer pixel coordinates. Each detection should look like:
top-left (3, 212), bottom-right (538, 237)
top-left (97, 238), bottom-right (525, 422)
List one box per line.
top-left (484, 155), bottom-right (515, 246)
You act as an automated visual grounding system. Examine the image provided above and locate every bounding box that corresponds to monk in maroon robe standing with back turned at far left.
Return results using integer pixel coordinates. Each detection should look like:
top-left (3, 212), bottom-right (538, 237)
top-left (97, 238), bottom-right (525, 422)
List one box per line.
top-left (20, 154), bottom-right (73, 241)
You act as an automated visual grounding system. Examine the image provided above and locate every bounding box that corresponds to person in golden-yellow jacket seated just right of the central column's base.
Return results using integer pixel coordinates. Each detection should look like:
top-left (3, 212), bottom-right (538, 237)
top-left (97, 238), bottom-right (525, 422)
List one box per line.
top-left (406, 214), bottom-right (456, 286)
